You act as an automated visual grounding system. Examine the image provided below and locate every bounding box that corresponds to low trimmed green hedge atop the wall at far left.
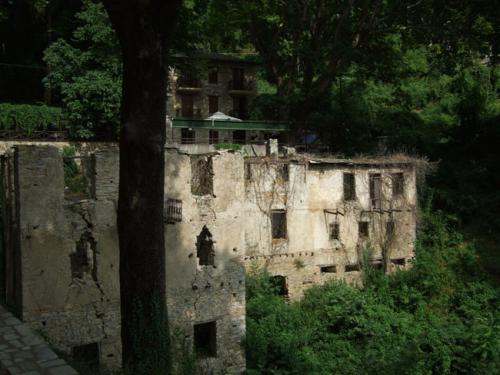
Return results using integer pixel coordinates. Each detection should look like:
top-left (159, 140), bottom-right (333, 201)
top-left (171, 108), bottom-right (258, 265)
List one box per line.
top-left (0, 103), bottom-right (62, 135)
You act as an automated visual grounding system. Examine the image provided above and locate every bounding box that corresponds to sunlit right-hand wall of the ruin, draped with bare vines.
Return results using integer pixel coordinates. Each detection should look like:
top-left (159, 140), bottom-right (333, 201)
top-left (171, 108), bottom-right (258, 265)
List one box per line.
top-left (244, 158), bottom-right (417, 299)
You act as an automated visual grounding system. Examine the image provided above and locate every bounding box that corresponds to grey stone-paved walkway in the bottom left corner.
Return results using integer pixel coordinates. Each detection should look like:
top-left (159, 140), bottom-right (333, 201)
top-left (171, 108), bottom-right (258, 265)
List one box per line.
top-left (0, 305), bottom-right (78, 375)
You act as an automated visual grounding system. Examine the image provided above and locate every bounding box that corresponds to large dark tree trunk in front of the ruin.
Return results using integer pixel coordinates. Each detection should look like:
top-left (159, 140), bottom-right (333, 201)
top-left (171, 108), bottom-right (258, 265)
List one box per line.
top-left (103, 0), bottom-right (180, 375)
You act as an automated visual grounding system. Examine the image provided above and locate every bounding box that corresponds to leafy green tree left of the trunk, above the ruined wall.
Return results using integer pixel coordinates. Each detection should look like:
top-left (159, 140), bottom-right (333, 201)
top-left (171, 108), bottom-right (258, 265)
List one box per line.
top-left (44, 0), bottom-right (121, 139)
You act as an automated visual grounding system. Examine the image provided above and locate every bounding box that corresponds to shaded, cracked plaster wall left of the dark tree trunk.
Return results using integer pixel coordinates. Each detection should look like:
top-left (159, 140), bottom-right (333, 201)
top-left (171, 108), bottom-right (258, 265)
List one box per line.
top-left (16, 146), bottom-right (121, 366)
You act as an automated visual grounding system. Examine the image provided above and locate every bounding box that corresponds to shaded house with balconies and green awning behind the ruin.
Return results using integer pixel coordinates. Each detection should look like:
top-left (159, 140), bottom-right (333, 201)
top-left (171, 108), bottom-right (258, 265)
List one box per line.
top-left (167, 54), bottom-right (289, 148)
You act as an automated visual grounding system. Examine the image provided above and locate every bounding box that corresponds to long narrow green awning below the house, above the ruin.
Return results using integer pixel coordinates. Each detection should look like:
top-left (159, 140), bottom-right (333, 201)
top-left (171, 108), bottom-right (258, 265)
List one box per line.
top-left (172, 119), bottom-right (290, 132)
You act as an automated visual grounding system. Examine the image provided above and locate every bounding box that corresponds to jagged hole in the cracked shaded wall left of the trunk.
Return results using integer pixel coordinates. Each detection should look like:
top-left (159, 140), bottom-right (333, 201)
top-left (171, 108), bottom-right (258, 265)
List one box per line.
top-left (70, 233), bottom-right (97, 279)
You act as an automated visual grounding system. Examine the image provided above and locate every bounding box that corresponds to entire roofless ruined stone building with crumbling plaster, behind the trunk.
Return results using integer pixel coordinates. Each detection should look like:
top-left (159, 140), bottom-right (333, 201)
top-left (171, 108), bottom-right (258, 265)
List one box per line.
top-left (1, 145), bottom-right (416, 374)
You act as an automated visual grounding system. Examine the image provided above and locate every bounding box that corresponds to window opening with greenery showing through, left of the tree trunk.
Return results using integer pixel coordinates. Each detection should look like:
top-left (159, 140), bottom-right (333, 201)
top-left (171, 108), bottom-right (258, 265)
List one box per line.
top-left (63, 153), bottom-right (95, 200)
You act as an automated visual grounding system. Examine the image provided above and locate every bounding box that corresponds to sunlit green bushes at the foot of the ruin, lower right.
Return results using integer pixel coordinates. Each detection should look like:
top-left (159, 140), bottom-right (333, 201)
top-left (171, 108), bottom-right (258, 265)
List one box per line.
top-left (247, 212), bottom-right (500, 375)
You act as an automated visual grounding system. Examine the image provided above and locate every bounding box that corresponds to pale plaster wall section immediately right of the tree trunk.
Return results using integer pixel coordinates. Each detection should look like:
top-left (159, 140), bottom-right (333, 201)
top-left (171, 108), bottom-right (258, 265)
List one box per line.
top-left (165, 150), bottom-right (245, 373)
